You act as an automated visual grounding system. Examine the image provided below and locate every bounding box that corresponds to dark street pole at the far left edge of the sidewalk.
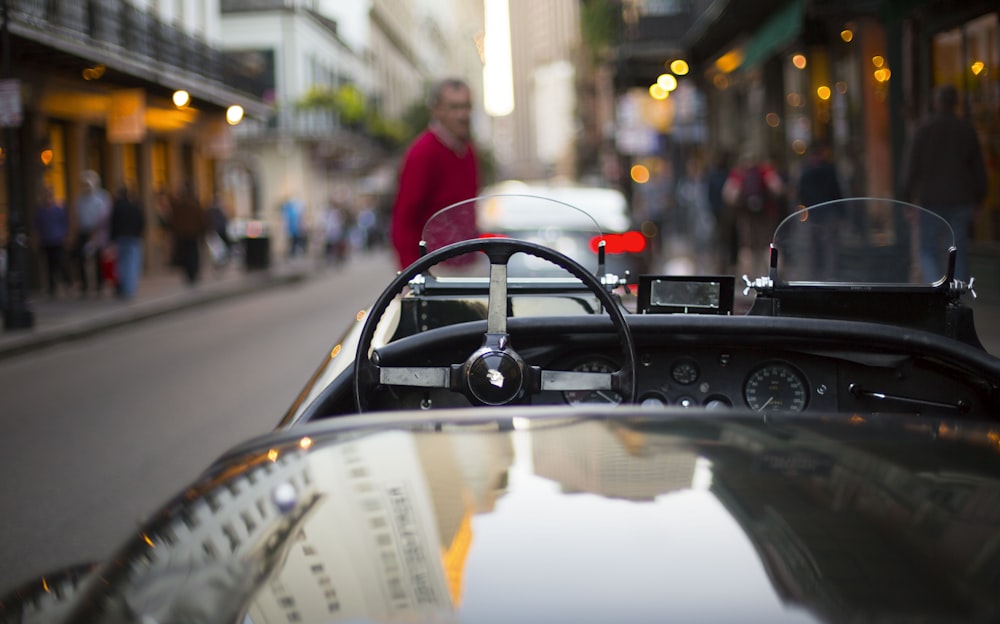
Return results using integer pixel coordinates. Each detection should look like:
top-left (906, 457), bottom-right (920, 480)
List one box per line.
top-left (0, 0), bottom-right (35, 330)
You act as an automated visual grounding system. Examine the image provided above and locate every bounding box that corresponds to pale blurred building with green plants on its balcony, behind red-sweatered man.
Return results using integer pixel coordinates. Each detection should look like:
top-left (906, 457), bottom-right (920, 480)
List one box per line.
top-left (221, 0), bottom-right (482, 254)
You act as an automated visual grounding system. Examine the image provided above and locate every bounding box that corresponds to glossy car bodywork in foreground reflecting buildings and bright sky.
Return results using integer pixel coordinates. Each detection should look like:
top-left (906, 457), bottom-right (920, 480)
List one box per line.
top-left (5, 408), bottom-right (1000, 623)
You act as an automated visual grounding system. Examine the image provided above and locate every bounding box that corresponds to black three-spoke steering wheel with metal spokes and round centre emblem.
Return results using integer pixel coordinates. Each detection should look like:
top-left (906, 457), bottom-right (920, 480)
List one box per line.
top-left (353, 238), bottom-right (637, 414)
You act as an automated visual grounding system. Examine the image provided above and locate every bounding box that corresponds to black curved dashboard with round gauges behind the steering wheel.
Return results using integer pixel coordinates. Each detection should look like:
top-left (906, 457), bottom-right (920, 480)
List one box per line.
top-left (360, 314), bottom-right (1000, 419)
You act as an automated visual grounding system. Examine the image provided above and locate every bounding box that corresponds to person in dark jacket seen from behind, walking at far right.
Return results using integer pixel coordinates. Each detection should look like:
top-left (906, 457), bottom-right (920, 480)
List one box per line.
top-left (900, 85), bottom-right (987, 282)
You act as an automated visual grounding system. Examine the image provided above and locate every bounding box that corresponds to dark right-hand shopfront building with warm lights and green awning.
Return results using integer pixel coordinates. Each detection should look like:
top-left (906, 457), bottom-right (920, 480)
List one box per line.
top-left (618, 0), bottom-right (1000, 282)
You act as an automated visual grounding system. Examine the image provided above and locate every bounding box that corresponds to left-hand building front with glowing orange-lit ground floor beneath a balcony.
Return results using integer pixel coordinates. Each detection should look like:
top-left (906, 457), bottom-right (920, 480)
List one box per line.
top-left (0, 0), bottom-right (267, 316)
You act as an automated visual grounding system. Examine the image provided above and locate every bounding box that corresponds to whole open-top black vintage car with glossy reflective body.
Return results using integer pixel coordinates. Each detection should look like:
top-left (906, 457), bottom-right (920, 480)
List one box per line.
top-left (0, 199), bottom-right (1000, 624)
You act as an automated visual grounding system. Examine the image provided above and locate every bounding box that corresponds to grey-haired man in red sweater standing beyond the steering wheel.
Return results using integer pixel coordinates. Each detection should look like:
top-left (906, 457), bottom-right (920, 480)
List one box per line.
top-left (391, 78), bottom-right (479, 268)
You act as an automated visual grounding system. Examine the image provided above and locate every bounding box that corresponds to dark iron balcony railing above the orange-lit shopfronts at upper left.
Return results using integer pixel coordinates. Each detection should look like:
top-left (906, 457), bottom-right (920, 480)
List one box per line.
top-left (7, 0), bottom-right (242, 94)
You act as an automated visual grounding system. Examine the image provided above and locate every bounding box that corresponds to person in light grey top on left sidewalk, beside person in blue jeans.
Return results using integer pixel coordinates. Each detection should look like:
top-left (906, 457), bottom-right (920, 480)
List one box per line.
top-left (72, 170), bottom-right (111, 296)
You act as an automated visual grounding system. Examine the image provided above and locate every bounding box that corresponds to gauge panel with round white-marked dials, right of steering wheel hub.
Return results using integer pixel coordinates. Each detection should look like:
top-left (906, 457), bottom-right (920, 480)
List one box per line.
top-left (561, 348), bottom-right (837, 413)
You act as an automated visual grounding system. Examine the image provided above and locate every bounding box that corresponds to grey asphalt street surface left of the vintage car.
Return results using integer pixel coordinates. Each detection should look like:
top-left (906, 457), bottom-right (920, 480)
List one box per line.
top-left (0, 247), bottom-right (394, 591)
